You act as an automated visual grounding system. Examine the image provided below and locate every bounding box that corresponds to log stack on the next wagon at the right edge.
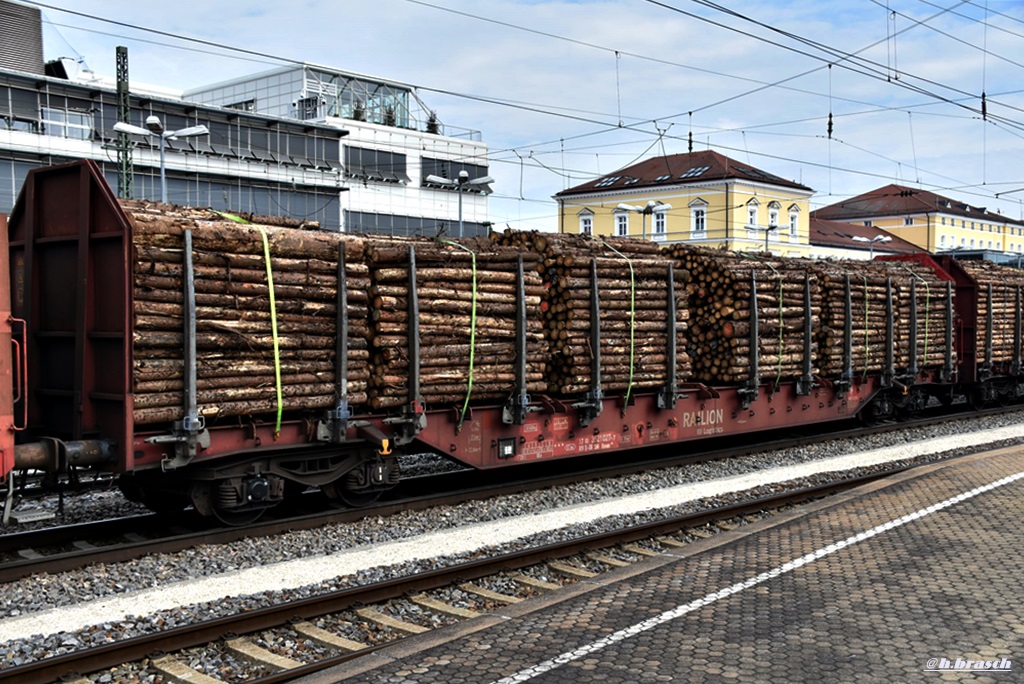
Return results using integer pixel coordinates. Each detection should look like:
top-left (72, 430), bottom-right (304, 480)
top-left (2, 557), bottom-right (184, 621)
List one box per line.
top-left (959, 261), bottom-right (1024, 364)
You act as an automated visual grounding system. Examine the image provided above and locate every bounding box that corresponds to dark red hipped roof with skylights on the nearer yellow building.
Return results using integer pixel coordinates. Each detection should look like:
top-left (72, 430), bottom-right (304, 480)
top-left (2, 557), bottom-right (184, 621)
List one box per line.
top-left (555, 149), bottom-right (813, 198)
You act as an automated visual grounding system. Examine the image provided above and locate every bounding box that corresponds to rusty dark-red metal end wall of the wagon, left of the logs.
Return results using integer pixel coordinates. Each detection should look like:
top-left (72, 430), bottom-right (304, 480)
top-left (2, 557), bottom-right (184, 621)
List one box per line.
top-left (8, 161), bottom-right (132, 470)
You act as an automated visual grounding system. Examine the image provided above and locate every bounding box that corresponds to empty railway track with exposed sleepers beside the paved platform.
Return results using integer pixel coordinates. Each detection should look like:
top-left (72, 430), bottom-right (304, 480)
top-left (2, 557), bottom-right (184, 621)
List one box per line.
top-left (2, 468), bottom-right (903, 684)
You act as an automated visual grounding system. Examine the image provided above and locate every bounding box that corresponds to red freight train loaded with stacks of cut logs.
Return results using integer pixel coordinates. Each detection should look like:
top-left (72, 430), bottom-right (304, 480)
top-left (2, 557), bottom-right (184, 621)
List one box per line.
top-left (0, 162), bottom-right (1024, 522)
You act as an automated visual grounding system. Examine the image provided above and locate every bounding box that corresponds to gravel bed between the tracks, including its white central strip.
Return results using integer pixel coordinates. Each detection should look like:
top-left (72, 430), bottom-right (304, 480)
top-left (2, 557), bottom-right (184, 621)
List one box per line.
top-left (0, 413), bottom-right (1024, 668)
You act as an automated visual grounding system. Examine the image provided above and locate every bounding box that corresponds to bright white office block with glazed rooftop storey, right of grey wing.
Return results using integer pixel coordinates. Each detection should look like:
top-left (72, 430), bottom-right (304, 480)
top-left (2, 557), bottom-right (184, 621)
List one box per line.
top-left (183, 63), bottom-right (490, 234)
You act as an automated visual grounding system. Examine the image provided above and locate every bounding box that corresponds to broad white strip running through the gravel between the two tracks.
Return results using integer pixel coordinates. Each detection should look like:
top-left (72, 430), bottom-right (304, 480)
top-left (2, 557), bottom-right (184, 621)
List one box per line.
top-left (0, 424), bottom-right (1024, 643)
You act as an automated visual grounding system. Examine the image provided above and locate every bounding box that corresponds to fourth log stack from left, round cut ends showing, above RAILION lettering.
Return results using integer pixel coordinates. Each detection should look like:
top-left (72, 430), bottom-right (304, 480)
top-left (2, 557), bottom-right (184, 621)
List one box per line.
top-left (665, 245), bottom-right (821, 383)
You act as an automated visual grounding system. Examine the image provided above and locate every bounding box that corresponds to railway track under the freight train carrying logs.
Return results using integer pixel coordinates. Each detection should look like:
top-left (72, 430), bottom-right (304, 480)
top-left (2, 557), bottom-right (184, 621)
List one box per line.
top-left (0, 408), bottom-right (1019, 582)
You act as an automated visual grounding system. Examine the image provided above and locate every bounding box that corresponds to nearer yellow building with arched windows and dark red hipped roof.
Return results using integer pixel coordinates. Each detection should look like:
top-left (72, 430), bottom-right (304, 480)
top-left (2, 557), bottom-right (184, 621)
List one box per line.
top-left (554, 151), bottom-right (814, 256)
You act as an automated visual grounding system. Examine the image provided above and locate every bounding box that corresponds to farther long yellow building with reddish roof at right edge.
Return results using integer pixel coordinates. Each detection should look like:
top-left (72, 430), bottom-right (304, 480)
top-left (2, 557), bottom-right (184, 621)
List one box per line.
top-left (814, 184), bottom-right (1024, 254)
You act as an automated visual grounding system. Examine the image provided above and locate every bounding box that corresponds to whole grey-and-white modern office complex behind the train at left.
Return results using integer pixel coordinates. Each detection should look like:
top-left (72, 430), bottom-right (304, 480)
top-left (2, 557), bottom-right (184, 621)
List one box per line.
top-left (0, 0), bottom-right (489, 236)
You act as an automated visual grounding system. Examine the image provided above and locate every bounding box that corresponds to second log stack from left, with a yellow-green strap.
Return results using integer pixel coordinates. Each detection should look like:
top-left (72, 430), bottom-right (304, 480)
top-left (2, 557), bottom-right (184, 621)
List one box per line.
top-left (368, 239), bottom-right (546, 409)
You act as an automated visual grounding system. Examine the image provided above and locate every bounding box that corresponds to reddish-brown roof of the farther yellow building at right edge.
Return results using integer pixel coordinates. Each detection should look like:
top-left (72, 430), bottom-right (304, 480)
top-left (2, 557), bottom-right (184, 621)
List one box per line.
top-left (812, 183), bottom-right (1024, 225)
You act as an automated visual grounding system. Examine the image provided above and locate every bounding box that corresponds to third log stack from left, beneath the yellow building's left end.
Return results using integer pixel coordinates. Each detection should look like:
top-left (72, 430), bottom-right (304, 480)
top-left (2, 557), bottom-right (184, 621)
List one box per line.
top-left (492, 230), bottom-right (692, 395)
